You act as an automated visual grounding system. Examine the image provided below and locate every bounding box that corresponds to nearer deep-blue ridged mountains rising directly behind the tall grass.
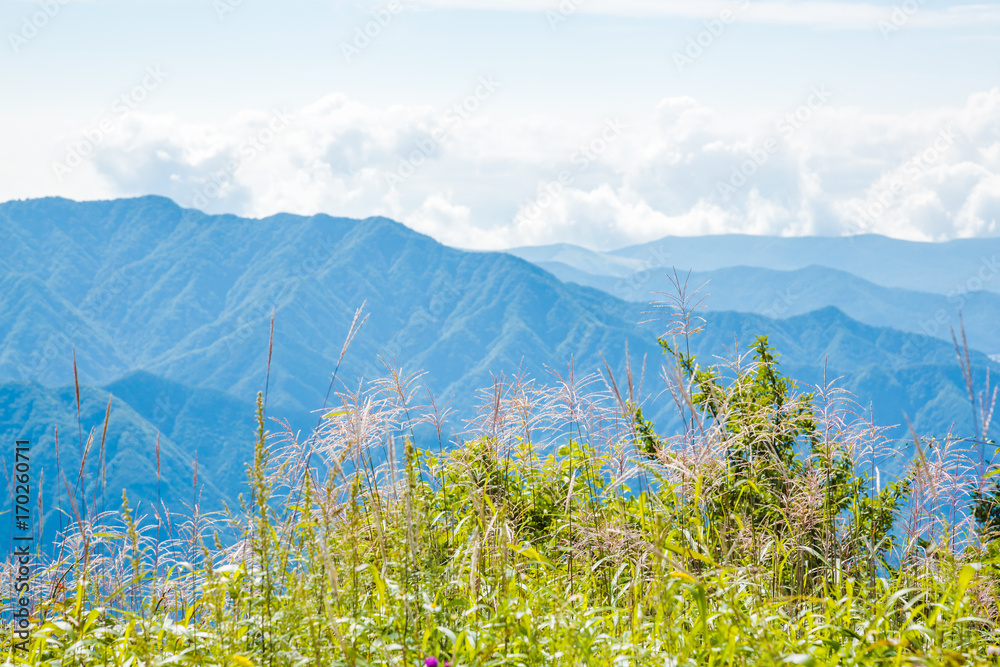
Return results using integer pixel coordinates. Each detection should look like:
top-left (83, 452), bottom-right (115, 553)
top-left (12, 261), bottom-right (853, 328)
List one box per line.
top-left (0, 197), bottom-right (996, 548)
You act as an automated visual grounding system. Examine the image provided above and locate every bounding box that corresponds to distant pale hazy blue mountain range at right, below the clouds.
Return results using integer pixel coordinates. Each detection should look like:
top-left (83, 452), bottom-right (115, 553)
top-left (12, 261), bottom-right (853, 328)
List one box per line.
top-left (510, 236), bottom-right (1000, 357)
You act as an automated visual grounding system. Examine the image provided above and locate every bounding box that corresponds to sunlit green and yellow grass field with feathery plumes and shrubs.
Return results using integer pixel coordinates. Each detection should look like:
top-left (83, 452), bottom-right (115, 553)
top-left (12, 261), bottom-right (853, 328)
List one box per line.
top-left (2, 299), bottom-right (1000, 667)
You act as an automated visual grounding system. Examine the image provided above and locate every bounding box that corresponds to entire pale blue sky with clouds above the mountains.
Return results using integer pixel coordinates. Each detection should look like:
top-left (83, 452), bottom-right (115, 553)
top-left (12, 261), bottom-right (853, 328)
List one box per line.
top-left (0, 0), bottom-right (1000, 250)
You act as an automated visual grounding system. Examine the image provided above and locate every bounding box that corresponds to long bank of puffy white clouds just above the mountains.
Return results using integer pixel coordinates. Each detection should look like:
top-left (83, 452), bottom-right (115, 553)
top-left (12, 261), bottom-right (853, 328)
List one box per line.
top-left (43, 89), bottom-right (1000, 248)
